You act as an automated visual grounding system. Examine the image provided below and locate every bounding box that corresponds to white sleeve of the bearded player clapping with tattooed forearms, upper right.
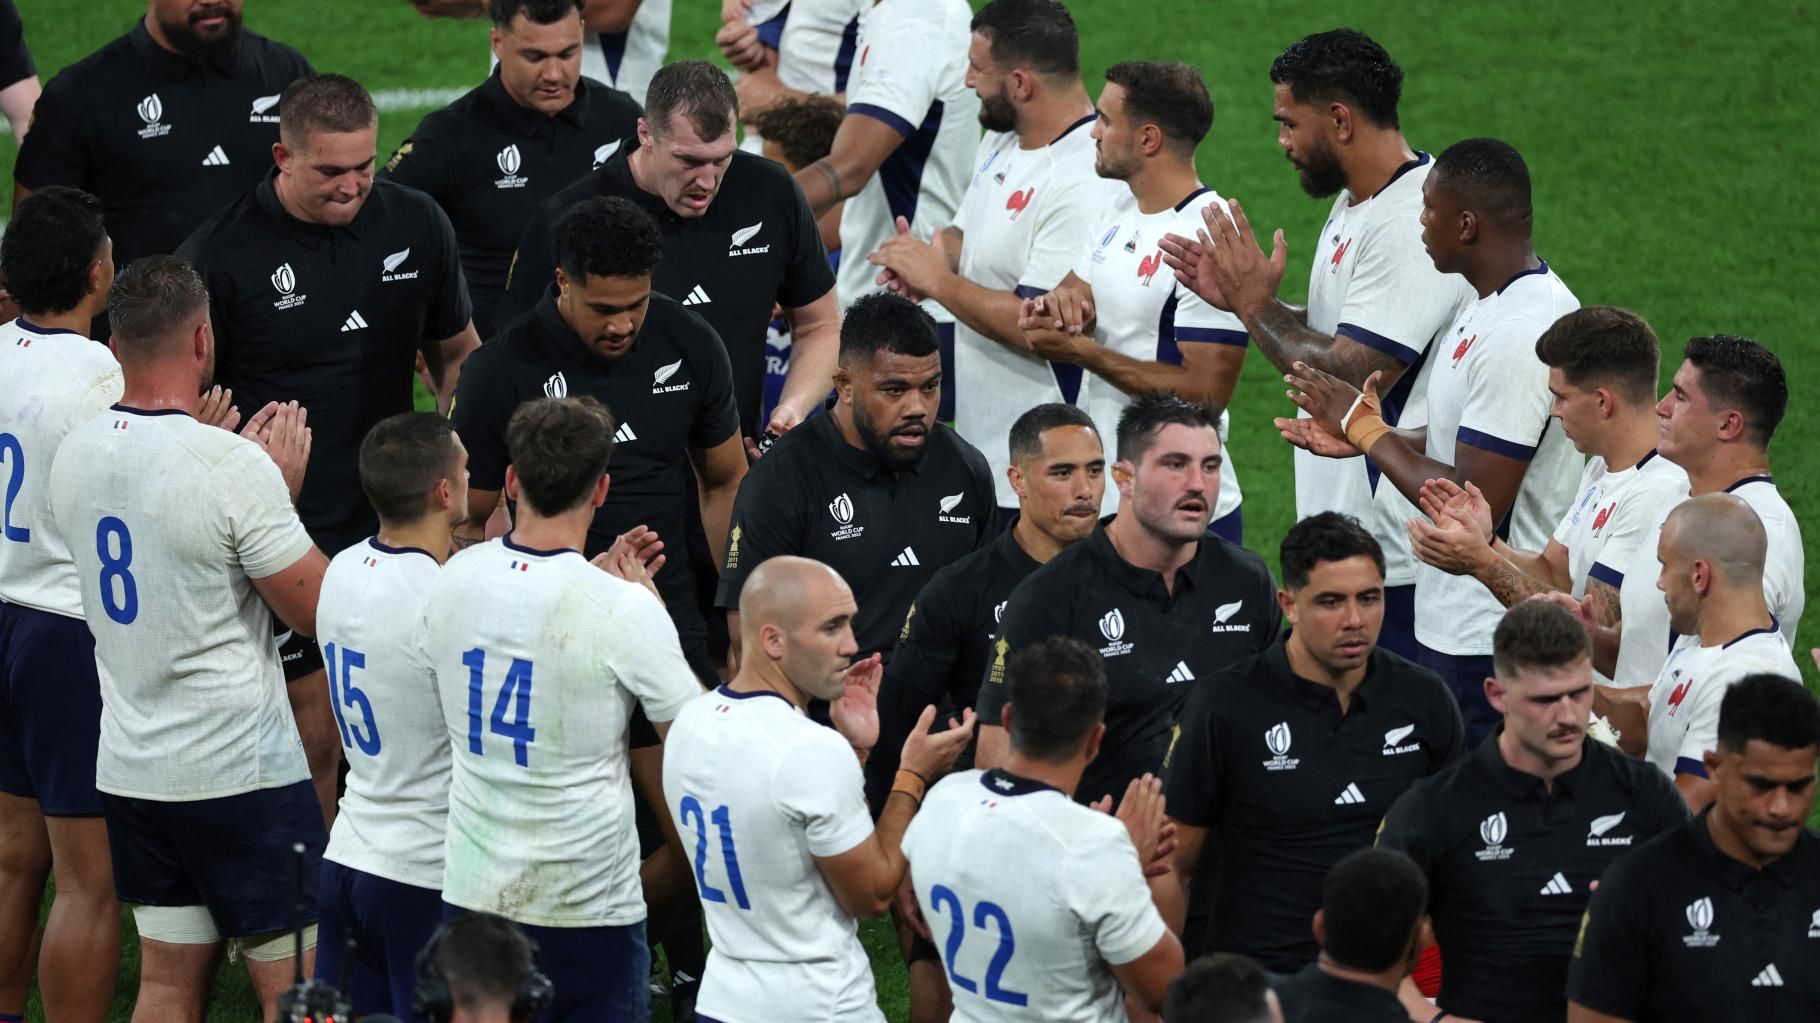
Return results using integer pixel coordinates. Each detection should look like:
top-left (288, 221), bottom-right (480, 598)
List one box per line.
top-left (1334, 215), bottom-right (1460, 366)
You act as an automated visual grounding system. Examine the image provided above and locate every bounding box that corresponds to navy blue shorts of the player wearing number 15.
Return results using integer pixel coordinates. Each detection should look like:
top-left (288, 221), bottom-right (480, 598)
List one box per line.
top-left (317, 859), bottom-right (442, 1019)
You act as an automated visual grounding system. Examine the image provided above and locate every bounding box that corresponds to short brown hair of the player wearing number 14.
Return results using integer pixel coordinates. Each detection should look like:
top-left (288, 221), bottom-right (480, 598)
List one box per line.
top-left (506, 395), bottom-right (617, 515)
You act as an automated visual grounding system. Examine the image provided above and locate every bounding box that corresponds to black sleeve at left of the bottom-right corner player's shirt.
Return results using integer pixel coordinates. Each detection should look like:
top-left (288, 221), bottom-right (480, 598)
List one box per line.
top-left (1567, 856), bottom-right (1651, 1019)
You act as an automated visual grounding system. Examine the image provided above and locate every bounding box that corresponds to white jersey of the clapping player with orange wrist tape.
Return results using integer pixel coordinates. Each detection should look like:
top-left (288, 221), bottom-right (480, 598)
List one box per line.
top-left (1405, 262), bottom-right (1582, 657)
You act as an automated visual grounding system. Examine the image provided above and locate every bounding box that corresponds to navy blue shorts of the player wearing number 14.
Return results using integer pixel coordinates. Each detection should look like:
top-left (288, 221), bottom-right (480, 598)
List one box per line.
top-left (442, 903), bottom-right (652, 1023)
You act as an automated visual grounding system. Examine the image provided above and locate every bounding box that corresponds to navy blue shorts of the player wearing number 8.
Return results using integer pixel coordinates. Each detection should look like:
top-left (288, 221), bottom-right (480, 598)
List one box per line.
top-left (102, 781), bottom-right (329, 937)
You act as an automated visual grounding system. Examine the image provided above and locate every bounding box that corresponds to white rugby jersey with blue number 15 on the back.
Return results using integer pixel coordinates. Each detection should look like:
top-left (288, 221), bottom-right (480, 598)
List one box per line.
top-left (317, 537), bottom-right (450, 890)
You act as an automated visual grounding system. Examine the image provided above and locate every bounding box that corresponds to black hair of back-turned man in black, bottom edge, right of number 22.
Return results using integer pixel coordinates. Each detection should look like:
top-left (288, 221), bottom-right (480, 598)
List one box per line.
top-left (1321, 848), bottom-right (1429, 974)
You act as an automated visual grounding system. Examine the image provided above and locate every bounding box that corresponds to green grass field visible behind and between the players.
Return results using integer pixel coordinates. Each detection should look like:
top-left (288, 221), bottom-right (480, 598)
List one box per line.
top-left (0, 0), bottom-right (1820, 1021)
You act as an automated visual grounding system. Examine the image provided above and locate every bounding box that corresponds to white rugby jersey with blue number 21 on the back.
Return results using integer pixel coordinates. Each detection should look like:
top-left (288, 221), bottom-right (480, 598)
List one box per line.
top-left (664, 686), bottom-right (885, 1023)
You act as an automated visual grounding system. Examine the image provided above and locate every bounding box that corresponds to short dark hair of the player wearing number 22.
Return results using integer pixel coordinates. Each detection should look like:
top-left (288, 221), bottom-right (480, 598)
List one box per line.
top-left (994, 635), bottom-right (1107, 761)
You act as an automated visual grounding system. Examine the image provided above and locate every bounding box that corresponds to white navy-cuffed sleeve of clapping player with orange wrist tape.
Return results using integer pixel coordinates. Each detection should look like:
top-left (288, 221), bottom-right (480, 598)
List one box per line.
top-left (1454, 319), bottom-right (1554, 462)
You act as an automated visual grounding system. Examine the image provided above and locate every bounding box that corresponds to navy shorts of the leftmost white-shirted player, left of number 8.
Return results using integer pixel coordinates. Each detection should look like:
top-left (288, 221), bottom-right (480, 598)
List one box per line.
top-left (0, 601), bottom-right (102, 817)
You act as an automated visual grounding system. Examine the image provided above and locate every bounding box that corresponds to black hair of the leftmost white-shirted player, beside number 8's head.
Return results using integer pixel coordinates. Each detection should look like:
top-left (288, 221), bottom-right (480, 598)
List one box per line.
top-left (0, 184), bottom-right (107, 313)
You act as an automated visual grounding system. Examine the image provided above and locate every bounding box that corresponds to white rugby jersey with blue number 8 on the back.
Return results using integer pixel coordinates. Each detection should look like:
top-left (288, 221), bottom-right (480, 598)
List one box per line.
top-left (51, 404), bottom-right (311, 803)
